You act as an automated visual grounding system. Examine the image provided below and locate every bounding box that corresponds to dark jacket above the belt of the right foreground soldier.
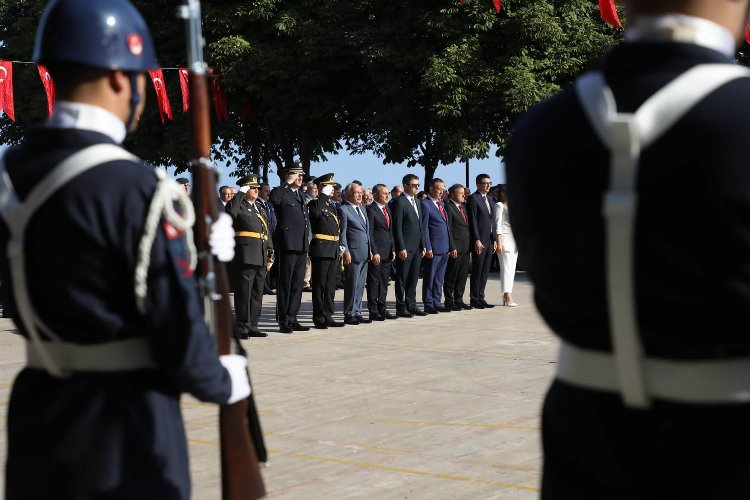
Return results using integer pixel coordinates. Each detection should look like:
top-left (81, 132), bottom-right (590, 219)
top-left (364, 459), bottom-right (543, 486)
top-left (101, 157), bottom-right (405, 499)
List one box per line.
top-left (506, 43), bottom-right (750, 358)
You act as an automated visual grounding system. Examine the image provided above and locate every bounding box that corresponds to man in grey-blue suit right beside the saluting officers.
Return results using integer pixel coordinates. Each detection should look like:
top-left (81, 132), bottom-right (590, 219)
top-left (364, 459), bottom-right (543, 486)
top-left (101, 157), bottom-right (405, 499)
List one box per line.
top-left (339, 183), bottom-right (371, 325)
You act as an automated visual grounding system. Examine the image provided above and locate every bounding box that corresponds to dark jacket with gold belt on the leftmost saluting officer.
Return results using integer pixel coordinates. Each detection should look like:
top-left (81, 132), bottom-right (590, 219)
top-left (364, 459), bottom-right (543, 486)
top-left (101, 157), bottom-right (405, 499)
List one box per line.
top-left (224, 192), bottom-right (273, 266)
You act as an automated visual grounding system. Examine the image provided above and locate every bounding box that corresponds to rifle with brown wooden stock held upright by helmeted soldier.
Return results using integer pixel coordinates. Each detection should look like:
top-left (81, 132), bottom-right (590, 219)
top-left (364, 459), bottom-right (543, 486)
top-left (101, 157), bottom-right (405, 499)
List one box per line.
top-left (178, 0), bottom-right (267, 500)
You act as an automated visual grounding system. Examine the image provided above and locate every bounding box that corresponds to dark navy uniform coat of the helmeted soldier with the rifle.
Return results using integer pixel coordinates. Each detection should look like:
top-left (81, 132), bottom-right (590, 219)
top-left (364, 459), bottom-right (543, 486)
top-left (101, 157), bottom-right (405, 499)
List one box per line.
top-left (0, 129), bottom-right (231, 499)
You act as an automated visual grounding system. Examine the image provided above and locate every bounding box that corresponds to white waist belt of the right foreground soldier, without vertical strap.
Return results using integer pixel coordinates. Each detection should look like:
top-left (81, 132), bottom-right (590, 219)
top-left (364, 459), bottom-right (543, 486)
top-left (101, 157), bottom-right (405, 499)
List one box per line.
top-left (557, 342), bottom-right (750, 404)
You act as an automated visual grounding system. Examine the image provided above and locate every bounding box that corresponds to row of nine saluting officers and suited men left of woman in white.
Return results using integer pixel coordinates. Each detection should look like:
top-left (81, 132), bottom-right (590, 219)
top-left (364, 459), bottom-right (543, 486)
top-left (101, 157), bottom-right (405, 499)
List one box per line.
top-left (224, 164), bottom-right (506, 338)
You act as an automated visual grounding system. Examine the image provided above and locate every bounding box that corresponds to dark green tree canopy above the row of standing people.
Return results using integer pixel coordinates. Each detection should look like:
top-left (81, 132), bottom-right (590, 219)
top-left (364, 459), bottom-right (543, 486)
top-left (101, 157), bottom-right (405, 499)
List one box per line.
top-left (0, 0), bottom-right (621, 184)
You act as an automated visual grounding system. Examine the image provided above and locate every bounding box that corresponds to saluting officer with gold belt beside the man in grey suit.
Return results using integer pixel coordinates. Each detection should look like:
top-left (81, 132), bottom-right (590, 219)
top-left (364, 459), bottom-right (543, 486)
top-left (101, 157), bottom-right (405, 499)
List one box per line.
top-left (307, 174), bottom-right (344, 329)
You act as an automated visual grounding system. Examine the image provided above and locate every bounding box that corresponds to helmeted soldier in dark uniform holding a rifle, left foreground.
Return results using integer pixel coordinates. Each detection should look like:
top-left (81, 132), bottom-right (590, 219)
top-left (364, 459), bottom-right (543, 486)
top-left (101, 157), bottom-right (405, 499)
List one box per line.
top-left (0, 0), bottom-right (249, 500)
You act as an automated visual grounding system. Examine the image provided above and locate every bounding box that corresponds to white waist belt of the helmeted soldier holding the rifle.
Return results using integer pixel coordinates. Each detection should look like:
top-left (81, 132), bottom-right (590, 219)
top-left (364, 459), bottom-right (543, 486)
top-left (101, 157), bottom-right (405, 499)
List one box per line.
top-left (26, 338), bottom-right (156, 372)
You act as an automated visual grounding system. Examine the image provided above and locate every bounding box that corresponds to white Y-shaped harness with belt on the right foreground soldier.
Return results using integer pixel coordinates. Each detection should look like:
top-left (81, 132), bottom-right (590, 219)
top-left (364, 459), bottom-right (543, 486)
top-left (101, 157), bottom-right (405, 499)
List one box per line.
top-left (557, 64), bottom-right (750, 408)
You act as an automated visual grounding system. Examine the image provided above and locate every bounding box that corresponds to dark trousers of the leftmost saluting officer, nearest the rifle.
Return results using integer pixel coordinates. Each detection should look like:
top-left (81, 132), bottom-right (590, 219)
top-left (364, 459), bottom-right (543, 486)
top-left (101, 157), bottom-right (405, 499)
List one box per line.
top-left (229, 263), bottom-right (266, 333)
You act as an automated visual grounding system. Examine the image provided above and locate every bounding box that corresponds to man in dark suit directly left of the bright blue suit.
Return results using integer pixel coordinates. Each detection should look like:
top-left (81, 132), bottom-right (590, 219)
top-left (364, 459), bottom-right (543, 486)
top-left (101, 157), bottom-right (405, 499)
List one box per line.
top-left (391, 174), bottom-right (427, 318)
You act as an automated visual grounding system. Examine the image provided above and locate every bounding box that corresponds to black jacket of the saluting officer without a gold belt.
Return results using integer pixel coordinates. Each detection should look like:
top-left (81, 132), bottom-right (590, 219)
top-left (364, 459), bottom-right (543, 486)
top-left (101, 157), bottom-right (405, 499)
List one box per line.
top-left (269, 184), bottom-right (310, 252)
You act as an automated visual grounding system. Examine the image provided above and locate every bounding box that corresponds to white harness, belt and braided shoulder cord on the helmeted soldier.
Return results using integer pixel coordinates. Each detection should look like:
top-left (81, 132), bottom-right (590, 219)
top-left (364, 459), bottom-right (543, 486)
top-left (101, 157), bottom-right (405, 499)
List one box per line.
top-left (0, 144), bottom-right (195, 377)
